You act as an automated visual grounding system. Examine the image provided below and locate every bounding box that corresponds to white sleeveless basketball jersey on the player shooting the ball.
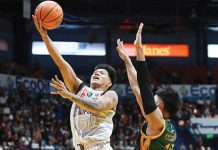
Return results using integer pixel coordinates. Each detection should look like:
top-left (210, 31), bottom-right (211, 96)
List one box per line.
top-left (70, 85), bottom-right (115, 147)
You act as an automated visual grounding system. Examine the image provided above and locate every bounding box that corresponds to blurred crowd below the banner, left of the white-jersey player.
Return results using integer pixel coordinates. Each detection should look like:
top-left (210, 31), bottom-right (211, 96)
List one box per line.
top-left (0, 87), bottom-right (72, 150)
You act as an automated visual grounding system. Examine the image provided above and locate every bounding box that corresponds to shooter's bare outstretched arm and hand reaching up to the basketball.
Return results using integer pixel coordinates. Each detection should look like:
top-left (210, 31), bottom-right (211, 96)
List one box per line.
top-left (32, 15), bottom-right (82, 93)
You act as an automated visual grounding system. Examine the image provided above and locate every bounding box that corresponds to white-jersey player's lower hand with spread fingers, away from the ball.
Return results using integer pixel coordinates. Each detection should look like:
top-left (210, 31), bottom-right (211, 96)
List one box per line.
top-left (50, 75), bottom-right (72, 98)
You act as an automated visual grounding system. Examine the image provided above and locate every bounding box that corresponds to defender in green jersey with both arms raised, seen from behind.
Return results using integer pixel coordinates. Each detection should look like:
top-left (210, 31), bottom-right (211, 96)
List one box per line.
top-left (116, 23), bottom-right (181, 150)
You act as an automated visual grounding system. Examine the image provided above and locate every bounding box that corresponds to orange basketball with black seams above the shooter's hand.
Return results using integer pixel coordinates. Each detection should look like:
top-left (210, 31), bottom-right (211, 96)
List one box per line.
top-left (35, 1), bottom-right (63, 30)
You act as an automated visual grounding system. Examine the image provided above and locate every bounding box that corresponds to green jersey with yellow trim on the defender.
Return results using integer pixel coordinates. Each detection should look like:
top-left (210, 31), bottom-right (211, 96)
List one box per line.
top-left (135, 120), bottom-right (176, 150)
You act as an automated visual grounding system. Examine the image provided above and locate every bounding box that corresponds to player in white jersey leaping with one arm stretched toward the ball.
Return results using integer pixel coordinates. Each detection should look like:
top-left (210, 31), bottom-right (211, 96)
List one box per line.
top-left (32, 16), bottom-right (118, 150)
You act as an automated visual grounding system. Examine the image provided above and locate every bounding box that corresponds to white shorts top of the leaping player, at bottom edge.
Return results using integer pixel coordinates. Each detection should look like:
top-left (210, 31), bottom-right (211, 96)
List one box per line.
top-left (75, 143), bottom-right (113, 150)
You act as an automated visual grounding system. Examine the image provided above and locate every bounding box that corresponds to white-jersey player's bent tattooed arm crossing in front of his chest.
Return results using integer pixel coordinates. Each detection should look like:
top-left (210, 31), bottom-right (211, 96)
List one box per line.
top-left (51, 76), bottom-right (118, 114)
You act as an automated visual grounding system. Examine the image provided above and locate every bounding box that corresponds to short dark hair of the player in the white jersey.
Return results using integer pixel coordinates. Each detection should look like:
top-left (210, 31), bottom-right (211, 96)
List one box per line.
top-left (94, 64), bottom-right (116, 85)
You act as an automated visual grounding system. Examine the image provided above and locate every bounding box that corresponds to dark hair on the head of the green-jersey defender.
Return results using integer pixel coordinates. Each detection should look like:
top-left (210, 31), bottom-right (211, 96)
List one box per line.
top-left (156, 88), bottom-right (182, 117)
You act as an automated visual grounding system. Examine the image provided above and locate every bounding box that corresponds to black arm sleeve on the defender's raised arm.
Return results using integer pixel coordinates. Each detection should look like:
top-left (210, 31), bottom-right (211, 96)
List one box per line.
top-left (136, 61), bottom-right (157, 115)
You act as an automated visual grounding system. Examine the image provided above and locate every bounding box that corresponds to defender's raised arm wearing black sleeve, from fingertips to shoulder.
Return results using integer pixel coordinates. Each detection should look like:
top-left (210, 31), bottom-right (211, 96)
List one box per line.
top-left (134, 23), bottom-right (164, 134)
